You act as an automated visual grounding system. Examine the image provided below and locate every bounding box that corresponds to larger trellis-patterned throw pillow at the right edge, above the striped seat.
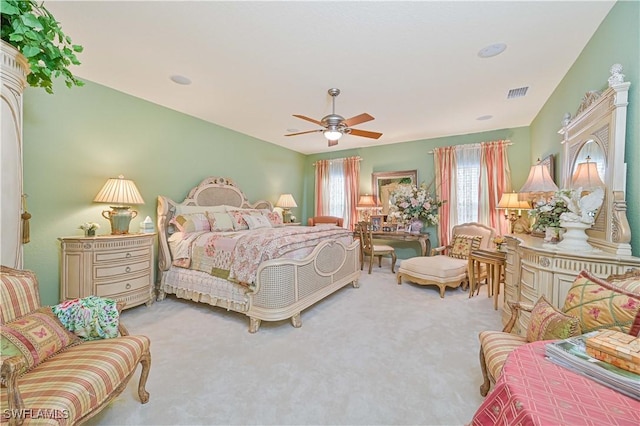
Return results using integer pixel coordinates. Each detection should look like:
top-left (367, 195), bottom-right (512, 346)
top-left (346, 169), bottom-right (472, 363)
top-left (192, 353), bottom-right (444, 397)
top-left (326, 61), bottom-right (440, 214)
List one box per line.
top-left (562, 271), bottom-right (640, 333)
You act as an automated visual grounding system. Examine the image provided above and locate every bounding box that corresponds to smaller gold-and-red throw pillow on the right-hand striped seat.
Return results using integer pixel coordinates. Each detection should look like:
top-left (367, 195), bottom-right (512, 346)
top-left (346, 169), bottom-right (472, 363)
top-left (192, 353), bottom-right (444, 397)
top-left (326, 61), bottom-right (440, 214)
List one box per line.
top-left (527, 296), bottom-right (581, 342)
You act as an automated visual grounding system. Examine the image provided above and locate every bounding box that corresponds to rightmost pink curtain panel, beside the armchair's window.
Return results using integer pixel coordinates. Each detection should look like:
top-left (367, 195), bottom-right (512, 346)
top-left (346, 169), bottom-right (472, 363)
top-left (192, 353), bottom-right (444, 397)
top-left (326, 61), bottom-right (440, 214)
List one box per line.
top-left (478, 140), bottom-right (511, 234)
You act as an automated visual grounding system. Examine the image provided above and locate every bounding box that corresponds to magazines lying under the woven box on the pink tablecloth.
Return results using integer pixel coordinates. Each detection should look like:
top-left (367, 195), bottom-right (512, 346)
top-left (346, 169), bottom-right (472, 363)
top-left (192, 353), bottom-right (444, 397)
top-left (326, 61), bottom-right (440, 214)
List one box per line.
top-left (545, 331), bottom-right (640, 400)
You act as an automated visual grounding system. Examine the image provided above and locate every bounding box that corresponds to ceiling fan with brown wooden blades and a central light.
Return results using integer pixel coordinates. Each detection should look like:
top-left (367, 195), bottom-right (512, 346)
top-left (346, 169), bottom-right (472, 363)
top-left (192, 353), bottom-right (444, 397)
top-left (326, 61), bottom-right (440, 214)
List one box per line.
top-left (285, 89), bottom-right (382, 146)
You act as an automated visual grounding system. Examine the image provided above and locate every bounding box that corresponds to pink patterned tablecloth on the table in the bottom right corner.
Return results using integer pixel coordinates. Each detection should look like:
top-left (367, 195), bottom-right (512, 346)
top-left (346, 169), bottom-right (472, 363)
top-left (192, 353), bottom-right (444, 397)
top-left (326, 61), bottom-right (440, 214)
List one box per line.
top-left (472, 342), bottom-right (640, 426)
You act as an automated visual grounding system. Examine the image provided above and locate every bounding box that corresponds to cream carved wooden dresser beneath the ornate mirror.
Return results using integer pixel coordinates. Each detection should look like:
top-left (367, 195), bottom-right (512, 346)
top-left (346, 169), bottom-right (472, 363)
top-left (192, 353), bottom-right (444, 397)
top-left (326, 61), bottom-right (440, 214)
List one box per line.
top-left (502, 234), bottom-right (640, 335)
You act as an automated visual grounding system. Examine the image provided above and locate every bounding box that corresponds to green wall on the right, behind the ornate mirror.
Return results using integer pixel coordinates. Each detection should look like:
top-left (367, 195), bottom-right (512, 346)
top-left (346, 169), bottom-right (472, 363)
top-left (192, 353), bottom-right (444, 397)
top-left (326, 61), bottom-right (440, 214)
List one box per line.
top-left (531, 1), bottom-right (640, 256)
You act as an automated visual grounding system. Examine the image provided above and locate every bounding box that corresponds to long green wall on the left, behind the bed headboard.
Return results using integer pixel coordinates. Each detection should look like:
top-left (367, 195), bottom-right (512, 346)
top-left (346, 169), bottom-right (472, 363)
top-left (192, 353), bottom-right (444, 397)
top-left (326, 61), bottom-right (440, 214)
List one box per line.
top-left (24, 82), bottom-right (305, 304)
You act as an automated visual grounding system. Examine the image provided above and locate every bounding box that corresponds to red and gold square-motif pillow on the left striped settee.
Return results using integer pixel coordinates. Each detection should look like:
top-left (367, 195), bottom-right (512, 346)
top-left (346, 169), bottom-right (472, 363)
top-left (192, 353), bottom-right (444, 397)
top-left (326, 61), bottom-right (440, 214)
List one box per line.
top-left (0, 306), bottom-right (80, 374)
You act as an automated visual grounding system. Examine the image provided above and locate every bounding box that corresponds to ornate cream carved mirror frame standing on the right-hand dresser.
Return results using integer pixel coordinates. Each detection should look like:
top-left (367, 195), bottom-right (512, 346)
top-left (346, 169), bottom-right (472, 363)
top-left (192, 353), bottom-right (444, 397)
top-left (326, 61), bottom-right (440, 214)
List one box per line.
top-left (558, 64), bottom-right (631, 256)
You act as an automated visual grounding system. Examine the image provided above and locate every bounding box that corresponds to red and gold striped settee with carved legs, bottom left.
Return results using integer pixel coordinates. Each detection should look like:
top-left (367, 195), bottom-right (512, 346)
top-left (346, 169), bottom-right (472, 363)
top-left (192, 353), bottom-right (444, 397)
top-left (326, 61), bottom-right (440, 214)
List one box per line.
top-left (0, 266), bottom-right (151, 425)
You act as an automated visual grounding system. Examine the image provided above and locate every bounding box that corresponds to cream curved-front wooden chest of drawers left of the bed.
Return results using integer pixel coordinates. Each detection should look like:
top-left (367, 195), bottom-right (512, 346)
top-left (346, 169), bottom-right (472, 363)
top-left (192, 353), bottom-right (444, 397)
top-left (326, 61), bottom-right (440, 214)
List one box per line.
top-left (59, 234), bottom-right (156, 309)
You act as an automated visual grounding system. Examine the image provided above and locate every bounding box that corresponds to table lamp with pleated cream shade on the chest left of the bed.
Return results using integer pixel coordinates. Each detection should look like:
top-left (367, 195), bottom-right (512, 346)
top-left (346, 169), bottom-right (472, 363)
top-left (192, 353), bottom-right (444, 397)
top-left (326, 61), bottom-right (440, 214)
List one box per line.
top-left (93, 175), bottom-right (144, 235)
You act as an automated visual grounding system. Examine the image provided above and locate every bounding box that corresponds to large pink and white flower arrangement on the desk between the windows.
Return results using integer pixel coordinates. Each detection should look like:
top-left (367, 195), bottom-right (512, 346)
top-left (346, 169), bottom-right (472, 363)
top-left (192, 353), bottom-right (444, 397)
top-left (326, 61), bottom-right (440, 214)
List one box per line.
top-left (389, 183), bottom-right (444, 226)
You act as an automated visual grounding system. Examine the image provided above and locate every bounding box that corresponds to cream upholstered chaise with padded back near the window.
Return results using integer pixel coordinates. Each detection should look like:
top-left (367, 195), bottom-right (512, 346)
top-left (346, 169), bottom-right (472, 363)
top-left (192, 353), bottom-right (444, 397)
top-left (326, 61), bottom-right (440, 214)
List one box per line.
top-left (398, 222), bottom-right (495, 297)
